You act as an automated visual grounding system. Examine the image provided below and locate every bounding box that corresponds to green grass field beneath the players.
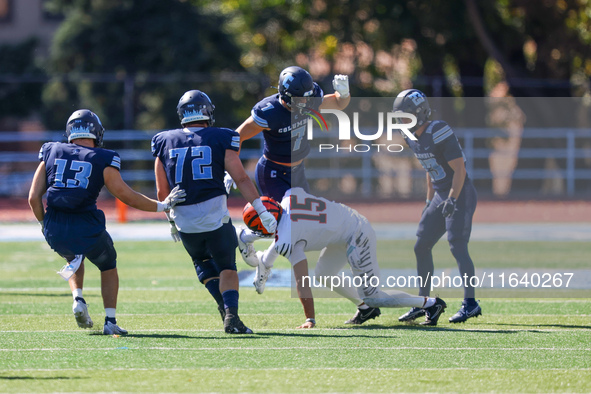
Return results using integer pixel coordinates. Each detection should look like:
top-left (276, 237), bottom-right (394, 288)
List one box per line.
top-left (0, 241), bottom-right (591, 393)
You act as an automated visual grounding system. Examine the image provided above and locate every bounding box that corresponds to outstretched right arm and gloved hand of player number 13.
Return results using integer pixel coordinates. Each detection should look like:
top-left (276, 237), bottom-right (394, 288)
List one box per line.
top-left (103, 167), bottom-right (185, 212)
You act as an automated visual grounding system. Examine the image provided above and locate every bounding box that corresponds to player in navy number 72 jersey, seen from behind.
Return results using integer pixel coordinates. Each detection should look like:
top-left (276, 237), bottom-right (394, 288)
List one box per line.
top-left (152, 90), bottom-right (277, 334)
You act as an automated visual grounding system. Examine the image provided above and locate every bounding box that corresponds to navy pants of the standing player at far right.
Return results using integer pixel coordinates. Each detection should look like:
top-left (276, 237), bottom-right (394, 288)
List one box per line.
top-left (414, 178), bottom-right (477, 298)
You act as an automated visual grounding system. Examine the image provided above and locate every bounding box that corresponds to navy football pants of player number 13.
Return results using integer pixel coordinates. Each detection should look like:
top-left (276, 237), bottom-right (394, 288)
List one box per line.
top-left (43, 207), bottom-right (117, 271)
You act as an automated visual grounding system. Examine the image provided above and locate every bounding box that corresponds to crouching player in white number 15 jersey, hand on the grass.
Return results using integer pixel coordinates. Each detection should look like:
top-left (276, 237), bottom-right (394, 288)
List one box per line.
top-left (245, 188), bottom-right (446, 328)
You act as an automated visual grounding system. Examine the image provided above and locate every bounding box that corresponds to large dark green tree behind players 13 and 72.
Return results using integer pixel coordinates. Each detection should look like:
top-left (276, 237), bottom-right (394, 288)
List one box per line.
top-left (44, 0), bottom-right (240, 129)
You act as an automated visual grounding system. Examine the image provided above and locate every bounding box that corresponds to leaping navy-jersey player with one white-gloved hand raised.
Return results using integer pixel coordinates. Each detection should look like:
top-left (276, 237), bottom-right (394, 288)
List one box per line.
top-left (231, 66), bottom-right (351, 266)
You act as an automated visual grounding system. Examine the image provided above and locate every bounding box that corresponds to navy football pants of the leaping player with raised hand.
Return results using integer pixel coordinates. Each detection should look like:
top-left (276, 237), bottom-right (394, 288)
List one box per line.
top-left (255, 156), bottom-right (310, 202)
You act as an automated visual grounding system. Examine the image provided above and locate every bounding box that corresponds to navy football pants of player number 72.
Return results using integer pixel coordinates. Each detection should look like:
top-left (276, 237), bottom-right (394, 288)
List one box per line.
top-left (179, 221), bottom-right (238, 283)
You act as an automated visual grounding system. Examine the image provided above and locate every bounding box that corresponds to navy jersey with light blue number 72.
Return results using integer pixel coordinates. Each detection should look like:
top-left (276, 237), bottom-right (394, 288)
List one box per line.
top-left (152, 127), bottom-right (240, 205)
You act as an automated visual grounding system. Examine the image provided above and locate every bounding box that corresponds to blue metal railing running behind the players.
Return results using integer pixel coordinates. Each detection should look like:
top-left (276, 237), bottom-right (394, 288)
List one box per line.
top-left (0, 128), bottom-right (591, 197)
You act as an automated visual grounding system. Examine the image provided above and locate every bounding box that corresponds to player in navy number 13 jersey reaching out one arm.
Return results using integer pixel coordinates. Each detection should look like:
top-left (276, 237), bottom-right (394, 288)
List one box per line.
top-left (29, 109), bottom-right (184, 335)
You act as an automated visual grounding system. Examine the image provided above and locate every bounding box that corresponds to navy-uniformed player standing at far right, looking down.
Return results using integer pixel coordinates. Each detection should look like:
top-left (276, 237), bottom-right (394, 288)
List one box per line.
top-left (393, 89), bottom-right (482, 323)
